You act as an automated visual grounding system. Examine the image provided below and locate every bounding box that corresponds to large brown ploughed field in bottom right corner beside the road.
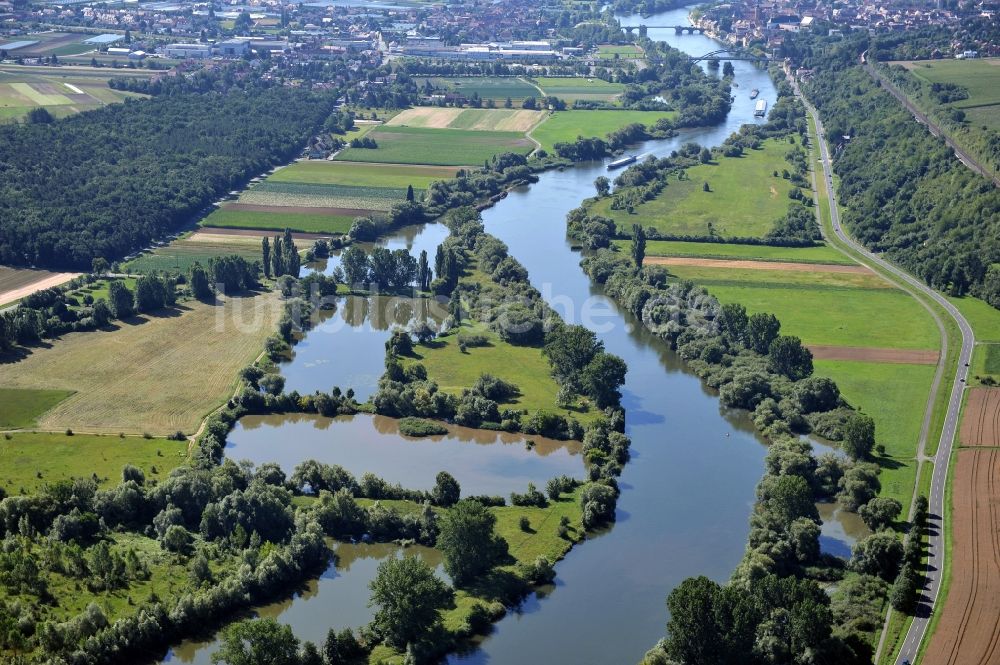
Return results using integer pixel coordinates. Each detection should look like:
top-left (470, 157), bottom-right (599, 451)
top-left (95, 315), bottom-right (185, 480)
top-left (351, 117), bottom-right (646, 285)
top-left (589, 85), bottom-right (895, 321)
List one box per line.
top-left (923, 449), bottom-right (1000, 665)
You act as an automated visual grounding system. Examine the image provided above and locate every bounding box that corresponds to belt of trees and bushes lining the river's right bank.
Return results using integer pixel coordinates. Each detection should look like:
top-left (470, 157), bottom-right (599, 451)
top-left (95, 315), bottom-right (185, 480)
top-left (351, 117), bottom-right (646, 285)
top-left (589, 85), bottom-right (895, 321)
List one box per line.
top-left (568, 89), bottom-right (919, 664)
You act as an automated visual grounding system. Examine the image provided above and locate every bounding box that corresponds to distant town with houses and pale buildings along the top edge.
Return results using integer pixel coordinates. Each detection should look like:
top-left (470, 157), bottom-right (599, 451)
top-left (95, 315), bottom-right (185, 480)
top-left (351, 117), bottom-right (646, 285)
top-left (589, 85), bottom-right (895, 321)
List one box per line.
top-left (0, 0), bottom-right (998, 68)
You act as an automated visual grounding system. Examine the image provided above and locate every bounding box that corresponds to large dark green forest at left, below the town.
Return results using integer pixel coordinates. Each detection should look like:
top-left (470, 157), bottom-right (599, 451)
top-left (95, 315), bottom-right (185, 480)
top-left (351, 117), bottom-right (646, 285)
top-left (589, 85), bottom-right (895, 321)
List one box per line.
top-left (0, 80), bottom-right (333, 270)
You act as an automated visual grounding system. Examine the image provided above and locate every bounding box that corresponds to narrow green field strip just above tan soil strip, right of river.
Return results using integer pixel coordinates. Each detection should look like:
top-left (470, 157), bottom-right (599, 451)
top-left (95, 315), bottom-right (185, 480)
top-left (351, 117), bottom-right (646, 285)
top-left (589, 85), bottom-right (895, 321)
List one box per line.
top-left (614, 240), bottom-right (854, 265)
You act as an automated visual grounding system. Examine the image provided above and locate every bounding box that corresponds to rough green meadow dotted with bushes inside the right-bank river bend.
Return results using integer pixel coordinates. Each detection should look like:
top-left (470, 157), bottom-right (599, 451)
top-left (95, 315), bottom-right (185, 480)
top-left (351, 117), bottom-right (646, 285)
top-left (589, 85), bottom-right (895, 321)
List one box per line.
top-left (588, 136), bottom-right (794, 238)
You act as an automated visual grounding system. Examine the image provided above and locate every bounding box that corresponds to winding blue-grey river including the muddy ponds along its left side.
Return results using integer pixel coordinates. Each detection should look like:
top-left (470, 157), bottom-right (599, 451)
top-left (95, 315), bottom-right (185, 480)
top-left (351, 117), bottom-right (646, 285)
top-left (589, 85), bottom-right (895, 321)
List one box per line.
top-left (162, 9), bottom-right (857, 665)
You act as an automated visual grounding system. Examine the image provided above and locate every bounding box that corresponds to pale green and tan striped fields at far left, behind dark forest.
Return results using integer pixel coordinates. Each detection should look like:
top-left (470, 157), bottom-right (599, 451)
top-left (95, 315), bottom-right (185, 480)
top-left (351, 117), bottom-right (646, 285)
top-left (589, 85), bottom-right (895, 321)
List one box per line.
top-left (0, 65), bottom-right (148, 121)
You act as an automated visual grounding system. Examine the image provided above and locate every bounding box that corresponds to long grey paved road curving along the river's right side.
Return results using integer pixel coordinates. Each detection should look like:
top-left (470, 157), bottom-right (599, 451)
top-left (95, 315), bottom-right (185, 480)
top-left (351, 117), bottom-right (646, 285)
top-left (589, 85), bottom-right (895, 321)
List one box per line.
top-left (794, 74), bottom-right (975, 663)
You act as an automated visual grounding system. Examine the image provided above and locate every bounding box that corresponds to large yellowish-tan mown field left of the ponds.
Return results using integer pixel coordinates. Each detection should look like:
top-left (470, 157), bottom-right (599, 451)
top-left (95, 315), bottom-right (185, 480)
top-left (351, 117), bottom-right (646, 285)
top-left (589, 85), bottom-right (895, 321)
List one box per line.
top-left (0, 294), bottom-right (280, 434)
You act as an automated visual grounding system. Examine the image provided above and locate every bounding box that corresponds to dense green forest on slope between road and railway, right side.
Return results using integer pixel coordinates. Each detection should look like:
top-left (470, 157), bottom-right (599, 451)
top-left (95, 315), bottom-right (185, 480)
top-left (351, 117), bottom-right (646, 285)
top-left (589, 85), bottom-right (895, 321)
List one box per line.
top-left (806, 42), bottom-right (1000, 307)
